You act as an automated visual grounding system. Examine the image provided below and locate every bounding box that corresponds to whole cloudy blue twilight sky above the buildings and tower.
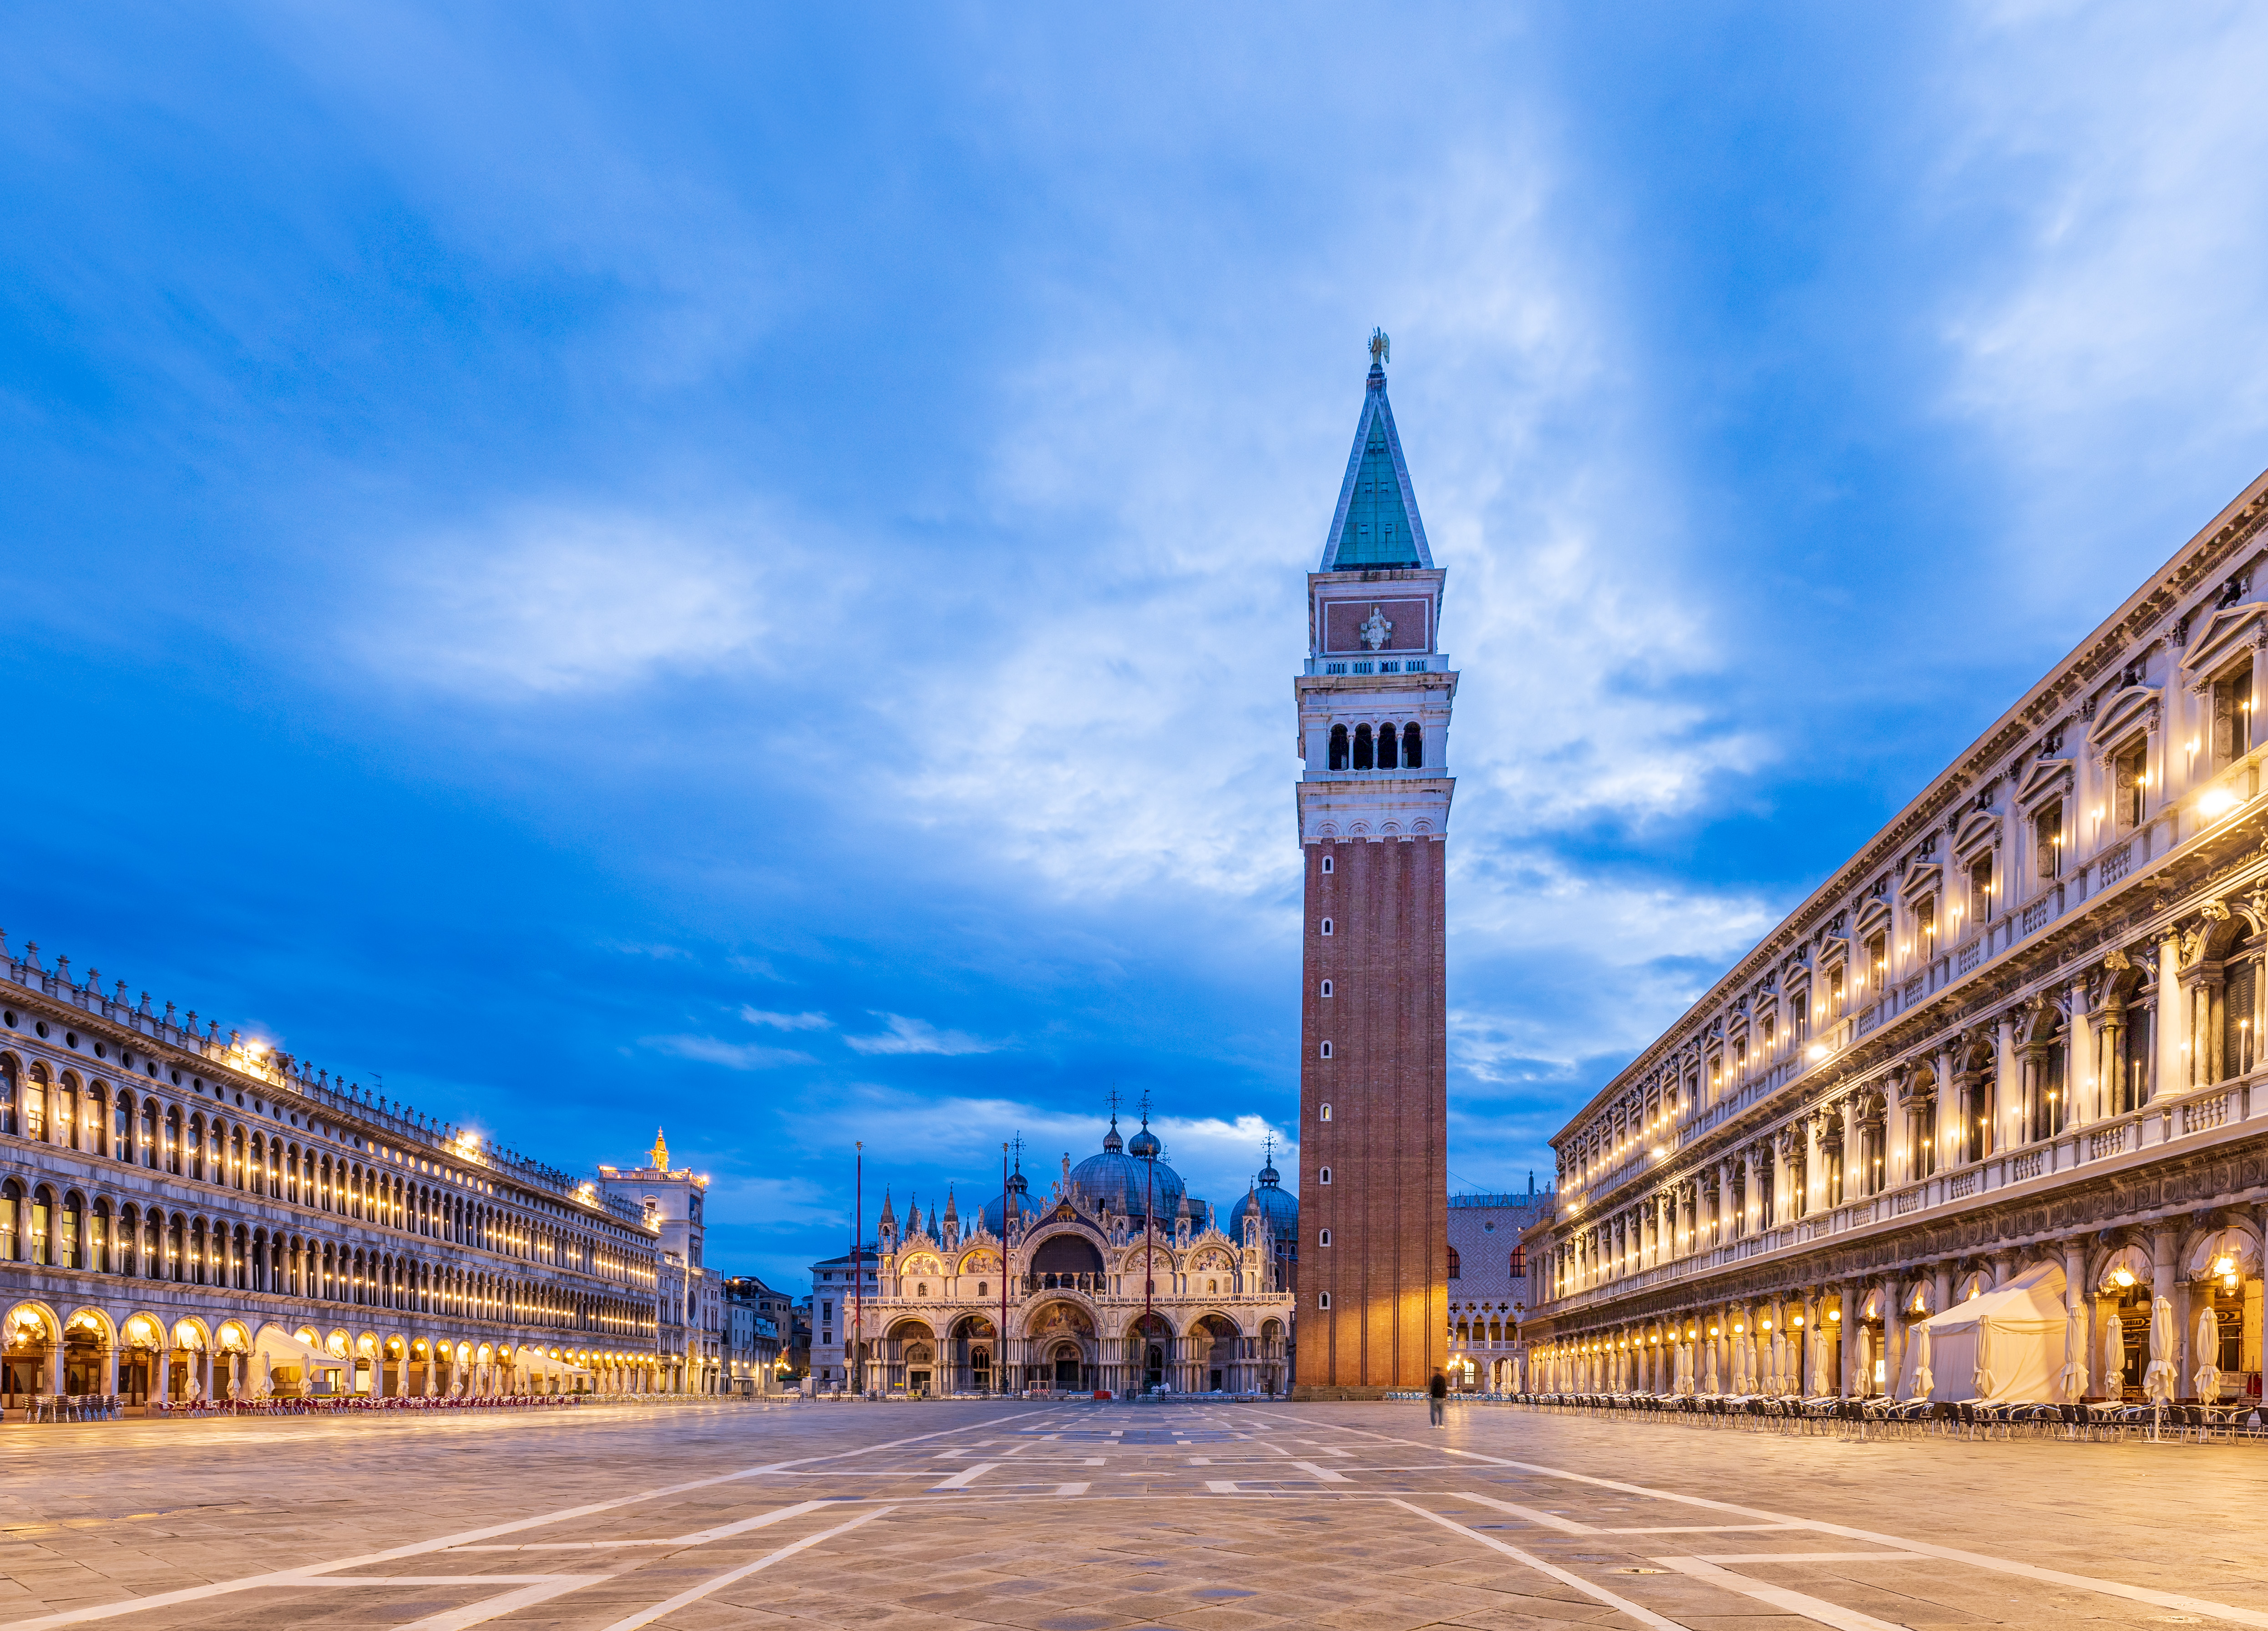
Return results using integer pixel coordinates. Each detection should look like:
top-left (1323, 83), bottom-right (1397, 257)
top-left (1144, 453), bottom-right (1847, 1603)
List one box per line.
top-left (0, 5), bottom-right (2268, 1284)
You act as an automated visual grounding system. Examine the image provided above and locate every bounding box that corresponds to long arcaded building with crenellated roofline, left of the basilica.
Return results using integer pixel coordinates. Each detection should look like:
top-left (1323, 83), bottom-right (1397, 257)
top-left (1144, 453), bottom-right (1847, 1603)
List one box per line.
top-left (0, 942), bottom-right (680, 1407)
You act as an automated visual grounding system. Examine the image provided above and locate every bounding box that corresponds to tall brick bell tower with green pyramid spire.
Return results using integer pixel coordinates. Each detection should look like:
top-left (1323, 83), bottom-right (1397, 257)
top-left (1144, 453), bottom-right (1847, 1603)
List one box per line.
top-left (1293, 334), bottom-right (1456, 1398)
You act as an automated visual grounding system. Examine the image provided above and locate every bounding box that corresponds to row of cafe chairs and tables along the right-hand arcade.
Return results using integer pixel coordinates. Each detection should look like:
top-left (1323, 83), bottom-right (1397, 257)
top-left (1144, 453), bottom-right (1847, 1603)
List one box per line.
top-left (1508, 1393), bottom-right (2268, 1443)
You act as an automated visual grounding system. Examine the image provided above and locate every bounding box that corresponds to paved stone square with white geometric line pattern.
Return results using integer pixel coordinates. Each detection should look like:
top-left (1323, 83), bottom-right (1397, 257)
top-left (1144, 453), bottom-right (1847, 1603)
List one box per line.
top-left (0, 1400), bottom-right (2268, 1631)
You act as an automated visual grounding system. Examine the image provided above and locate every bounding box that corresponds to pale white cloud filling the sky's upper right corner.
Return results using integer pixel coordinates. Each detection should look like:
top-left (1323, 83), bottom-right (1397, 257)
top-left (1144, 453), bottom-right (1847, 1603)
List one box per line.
top-left (1923, 5), bottom-right (2268, 585)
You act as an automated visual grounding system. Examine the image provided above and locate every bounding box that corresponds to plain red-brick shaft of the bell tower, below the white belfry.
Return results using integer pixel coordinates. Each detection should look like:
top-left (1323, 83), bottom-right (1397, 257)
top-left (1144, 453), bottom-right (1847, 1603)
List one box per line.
top-left (1297, 839), bottom-right (1449, 1393)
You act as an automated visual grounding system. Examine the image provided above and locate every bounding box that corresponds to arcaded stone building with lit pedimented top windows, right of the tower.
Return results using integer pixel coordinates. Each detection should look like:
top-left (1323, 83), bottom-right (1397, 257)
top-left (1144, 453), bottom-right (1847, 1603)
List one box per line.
top-left (1524, 476), bottom-right (2268, 1400)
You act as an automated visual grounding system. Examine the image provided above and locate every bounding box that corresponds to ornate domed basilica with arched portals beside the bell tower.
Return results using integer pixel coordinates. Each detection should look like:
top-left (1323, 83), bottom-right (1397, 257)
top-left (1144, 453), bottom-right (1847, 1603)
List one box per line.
top-left (812, 1116), bottom-right (1300, 1395)
